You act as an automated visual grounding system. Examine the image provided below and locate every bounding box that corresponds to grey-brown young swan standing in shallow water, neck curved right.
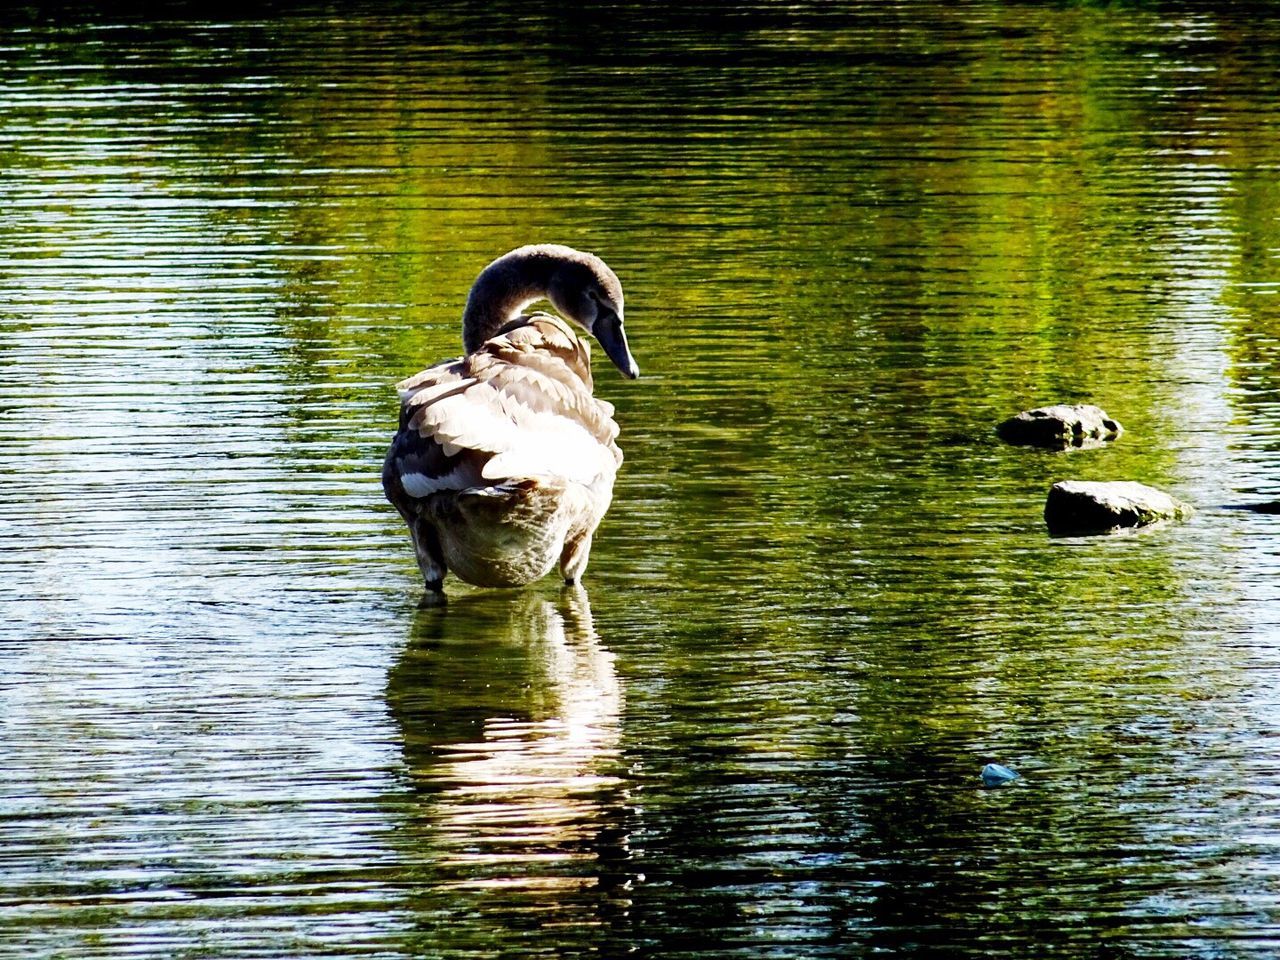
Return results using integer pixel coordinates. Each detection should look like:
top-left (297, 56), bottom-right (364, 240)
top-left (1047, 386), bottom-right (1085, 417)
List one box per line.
top-left (383, 243), bottom-right (640, 593)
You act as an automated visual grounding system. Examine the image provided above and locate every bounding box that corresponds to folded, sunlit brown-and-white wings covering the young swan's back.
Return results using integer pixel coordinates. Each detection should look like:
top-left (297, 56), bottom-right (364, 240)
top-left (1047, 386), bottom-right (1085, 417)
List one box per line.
top-left (390, 316), bottom-right (622, 497)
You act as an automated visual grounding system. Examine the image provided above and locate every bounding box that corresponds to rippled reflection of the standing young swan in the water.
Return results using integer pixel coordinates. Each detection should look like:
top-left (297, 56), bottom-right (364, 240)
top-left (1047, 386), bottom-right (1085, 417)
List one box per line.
top-left (387, 588), bottom-right (636, 946)
